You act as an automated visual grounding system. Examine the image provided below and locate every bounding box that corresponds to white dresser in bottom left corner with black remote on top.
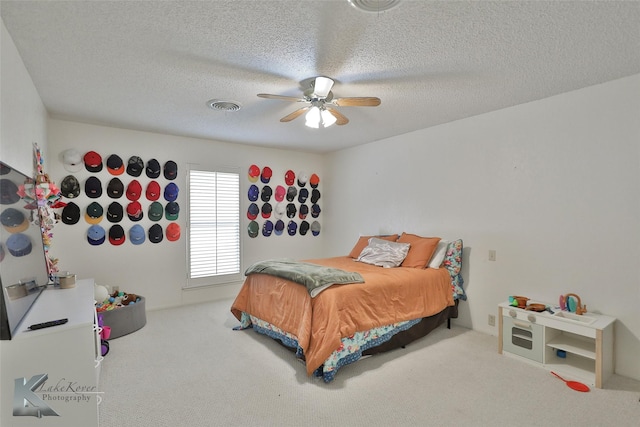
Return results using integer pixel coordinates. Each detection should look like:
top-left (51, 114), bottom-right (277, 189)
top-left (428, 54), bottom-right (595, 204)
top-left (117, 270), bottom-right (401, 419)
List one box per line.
top-left (0, 279), bottom-right (102, 427)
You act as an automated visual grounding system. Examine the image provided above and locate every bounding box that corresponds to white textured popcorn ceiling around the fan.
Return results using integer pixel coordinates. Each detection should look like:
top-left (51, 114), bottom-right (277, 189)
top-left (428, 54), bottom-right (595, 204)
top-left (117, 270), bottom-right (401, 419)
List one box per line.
top-left (0, 0), bottom-right (640, 152)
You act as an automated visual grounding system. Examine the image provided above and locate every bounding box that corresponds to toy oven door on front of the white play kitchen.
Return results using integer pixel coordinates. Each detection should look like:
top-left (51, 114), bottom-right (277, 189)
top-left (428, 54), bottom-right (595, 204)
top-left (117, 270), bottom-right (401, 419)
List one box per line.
top-left (502, 316), bottom-right (544, 363)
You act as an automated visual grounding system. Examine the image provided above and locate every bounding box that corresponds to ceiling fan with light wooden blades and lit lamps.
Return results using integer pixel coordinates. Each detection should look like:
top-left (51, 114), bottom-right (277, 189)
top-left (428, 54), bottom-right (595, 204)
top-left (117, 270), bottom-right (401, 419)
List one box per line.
top-left (258, 76), bottom-right (380, 128)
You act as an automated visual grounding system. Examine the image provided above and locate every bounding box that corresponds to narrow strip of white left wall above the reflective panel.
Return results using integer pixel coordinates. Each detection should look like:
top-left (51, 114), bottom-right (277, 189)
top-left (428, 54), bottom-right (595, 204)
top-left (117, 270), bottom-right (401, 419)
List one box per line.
top-left (0, 22), bottom-right (47, 175)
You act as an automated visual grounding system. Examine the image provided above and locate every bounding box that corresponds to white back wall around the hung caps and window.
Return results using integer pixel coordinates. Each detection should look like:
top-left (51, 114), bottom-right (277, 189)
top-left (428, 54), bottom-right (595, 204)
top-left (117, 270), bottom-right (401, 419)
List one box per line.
top-left (48, 120), bottom-right (325, 309)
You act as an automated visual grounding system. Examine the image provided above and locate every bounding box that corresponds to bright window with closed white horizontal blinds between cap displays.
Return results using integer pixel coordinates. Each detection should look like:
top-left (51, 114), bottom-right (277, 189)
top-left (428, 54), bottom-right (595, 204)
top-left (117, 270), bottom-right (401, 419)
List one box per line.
top-left (187, 169), bottom-right (242, 287)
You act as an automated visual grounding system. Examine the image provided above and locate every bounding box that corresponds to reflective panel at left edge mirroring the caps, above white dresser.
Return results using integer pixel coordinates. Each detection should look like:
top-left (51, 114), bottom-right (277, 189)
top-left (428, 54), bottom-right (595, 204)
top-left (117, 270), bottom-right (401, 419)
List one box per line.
top-left (0, 162), bottom-right (49, 340)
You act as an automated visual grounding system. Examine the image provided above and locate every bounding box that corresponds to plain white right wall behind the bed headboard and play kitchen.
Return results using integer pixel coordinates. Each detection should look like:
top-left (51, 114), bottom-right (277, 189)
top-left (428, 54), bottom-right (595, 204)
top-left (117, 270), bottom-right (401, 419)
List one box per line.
top-left (325, 75), bottom-right (640, 379)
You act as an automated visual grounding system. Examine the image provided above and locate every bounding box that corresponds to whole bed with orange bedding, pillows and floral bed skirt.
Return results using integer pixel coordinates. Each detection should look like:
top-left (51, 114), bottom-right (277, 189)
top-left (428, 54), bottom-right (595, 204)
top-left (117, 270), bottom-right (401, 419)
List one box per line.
top-left (231, 233), bottom-right (466, 382)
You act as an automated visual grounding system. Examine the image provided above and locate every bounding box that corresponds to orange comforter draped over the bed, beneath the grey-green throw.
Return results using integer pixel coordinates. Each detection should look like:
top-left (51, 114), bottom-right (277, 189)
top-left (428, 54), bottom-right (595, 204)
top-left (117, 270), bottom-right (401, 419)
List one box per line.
top-left (231, 256), bottom-right (454, 375)
